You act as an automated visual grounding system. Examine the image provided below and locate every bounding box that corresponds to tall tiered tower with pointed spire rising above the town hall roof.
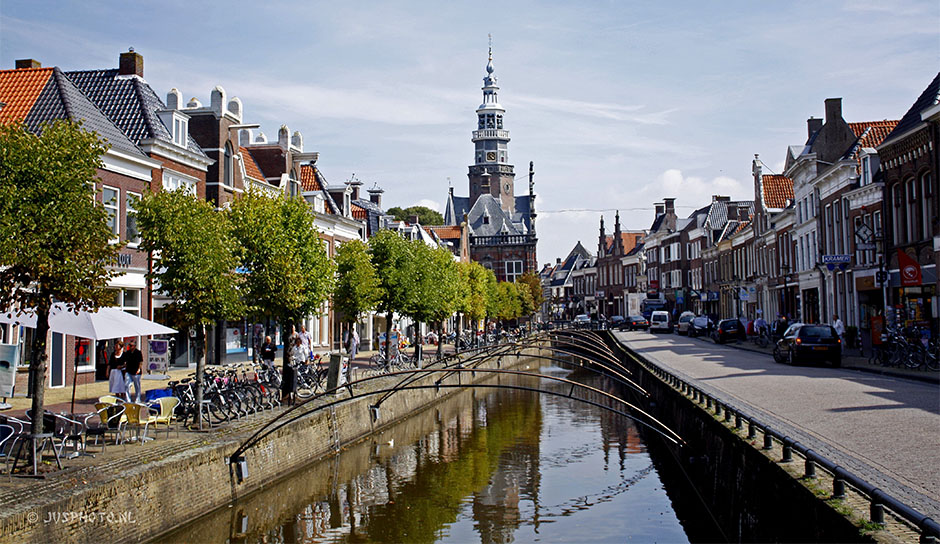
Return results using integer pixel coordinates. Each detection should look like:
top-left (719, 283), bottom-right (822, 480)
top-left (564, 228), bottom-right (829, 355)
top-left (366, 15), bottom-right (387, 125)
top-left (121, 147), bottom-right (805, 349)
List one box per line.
top-left (468, 43), bottom-right (515, 213)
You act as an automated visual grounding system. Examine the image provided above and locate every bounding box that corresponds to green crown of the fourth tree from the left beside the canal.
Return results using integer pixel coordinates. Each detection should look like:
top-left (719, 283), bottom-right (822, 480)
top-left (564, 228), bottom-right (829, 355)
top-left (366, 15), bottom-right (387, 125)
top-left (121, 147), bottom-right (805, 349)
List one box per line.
top-left (333, 240), bottom-right (382, 330)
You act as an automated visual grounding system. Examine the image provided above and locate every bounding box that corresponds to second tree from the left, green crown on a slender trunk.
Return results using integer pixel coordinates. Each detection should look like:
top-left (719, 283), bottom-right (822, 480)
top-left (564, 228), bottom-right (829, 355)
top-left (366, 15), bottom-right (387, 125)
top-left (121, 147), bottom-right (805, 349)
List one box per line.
top-left (137, 191), bottom-right (244, 428)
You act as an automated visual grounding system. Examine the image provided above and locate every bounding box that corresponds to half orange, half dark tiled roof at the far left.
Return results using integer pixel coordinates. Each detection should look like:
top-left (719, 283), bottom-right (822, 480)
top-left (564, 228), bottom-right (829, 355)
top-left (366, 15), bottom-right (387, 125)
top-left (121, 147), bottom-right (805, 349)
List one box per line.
top-left (0, 68), bottom-right (146, 157)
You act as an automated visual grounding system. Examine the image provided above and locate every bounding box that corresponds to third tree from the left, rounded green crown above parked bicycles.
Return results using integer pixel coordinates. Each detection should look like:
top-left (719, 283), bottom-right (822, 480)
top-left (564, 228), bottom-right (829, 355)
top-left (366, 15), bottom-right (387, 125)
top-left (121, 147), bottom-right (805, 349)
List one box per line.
top-left (228, 190), bottom-right (334, 364)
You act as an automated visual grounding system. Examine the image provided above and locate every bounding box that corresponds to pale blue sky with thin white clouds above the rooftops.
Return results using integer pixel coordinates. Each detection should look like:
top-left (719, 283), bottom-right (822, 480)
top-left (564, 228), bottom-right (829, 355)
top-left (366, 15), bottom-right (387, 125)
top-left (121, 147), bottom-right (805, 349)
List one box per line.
top-left (0, 0), bottom-right (940, 263)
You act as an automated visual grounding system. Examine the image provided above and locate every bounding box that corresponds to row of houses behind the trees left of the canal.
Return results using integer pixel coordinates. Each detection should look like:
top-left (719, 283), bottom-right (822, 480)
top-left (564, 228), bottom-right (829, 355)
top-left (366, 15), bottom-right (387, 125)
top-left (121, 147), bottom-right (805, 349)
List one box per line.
top-left (0, 49), bottom-right (456, 390)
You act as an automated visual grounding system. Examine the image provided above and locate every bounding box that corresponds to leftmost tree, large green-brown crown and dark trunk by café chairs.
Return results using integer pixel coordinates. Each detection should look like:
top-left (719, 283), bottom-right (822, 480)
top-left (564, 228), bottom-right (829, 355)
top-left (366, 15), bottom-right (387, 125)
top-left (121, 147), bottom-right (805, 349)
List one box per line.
top-left (0, 121), bottom-right (120, 434)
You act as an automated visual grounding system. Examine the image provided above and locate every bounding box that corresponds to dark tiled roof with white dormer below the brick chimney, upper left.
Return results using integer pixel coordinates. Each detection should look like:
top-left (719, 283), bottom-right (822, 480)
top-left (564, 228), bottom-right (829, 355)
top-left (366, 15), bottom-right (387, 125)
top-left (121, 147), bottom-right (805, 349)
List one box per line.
top-left (65, 68), bottom-right (208, 158)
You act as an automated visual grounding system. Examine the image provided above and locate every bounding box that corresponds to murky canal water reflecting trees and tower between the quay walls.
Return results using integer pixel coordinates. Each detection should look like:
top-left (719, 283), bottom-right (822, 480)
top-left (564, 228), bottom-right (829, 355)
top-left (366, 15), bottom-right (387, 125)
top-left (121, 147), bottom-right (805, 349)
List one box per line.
top-left (160, 367), bottom-right (721, 543)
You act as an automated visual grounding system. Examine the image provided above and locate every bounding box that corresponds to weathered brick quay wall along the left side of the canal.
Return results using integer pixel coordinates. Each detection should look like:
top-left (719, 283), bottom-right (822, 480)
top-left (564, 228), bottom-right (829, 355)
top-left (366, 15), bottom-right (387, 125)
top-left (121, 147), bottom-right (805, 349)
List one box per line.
top-left (0, 350), bottom-right (540, 544)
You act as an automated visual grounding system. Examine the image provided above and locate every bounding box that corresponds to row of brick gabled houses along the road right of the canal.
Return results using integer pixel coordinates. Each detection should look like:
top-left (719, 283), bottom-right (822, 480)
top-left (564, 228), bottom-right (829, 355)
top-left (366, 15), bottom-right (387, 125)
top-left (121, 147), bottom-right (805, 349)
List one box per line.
top-left (542, 74), bottom-right (940, 344)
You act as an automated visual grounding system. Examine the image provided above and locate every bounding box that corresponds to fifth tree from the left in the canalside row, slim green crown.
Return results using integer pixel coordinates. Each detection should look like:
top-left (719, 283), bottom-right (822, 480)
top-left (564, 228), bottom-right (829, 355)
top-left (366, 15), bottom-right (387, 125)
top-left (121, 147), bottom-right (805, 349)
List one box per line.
top-left (369, 230), bottom-right (415, 357)
